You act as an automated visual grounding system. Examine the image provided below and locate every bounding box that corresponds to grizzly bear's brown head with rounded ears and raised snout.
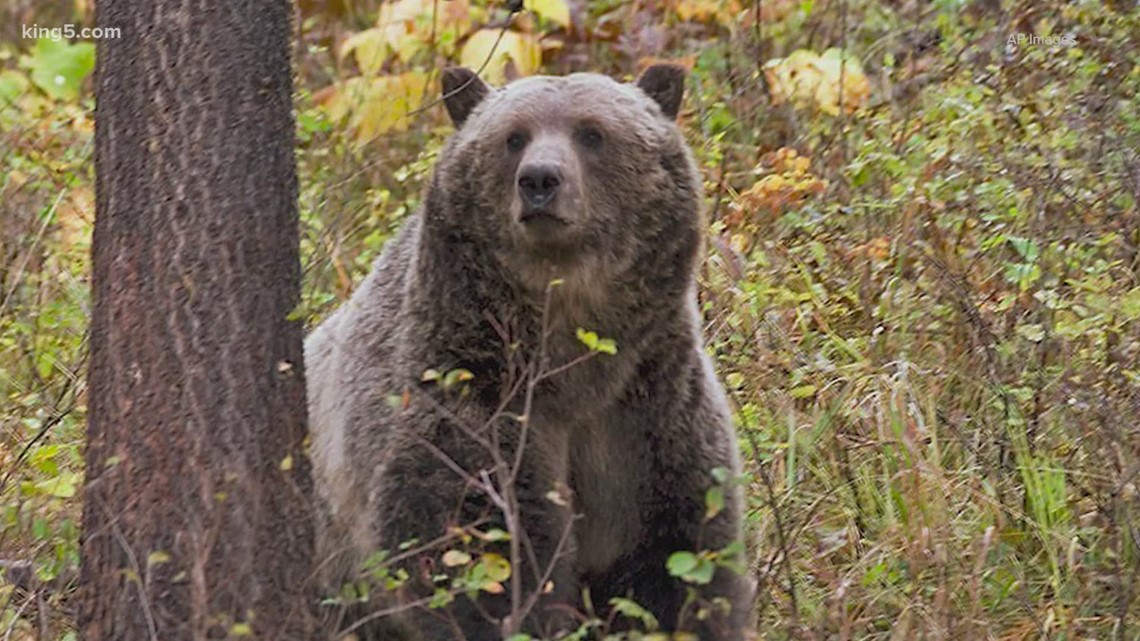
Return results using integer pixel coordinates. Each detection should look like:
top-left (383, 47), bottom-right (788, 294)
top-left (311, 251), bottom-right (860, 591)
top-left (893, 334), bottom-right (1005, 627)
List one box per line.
top-left (426, 64), bottom-right (702, 298)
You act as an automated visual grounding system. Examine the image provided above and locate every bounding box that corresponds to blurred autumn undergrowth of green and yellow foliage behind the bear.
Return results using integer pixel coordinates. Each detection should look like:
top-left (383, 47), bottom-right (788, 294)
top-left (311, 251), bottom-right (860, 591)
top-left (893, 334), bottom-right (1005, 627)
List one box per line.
top-left (0, 0), bottom-right (1140, 641)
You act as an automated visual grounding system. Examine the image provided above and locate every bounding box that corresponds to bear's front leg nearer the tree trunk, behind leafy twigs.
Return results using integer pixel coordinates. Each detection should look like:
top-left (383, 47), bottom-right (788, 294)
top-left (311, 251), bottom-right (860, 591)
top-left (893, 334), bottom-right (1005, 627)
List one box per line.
top-left (376, 410), bottom-right (578, 641)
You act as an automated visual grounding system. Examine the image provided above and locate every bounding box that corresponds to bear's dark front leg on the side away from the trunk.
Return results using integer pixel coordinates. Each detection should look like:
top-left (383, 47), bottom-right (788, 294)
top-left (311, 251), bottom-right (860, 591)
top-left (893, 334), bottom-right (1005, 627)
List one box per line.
top-left (573, 355), bottom-right (752, 641)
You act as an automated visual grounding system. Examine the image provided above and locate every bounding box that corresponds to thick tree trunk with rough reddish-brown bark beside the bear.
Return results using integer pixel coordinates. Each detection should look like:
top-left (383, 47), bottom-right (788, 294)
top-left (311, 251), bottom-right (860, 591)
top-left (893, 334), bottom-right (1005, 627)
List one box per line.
top-left (79, 0), bottom-right (315, 641)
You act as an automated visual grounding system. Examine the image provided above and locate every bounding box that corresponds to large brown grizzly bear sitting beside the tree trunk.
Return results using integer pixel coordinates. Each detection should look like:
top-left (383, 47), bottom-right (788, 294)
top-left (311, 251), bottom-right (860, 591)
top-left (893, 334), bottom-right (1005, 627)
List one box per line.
top-left (306, 64), bottom-right (751, 641)
